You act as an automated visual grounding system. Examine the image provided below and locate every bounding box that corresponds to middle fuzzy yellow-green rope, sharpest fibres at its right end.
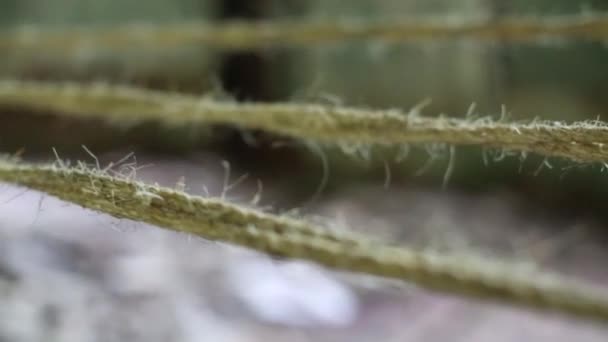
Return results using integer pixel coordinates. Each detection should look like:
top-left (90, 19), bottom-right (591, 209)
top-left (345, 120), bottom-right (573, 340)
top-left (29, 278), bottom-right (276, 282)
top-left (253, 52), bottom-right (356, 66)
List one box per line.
top-left (0, 81), bottom-right (608, 162)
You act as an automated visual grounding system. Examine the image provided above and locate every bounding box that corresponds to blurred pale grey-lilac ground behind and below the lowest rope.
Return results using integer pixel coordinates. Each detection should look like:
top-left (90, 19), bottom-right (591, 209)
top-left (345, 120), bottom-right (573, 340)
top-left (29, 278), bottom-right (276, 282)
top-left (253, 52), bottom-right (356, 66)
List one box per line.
top-left (0, 153), bottom-right (608, 342)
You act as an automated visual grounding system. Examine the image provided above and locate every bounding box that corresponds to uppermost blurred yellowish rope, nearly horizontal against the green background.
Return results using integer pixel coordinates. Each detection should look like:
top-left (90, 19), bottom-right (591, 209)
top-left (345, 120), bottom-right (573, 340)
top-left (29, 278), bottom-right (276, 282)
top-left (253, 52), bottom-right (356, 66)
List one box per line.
top-left (0, 13), bottom-right (608, 49)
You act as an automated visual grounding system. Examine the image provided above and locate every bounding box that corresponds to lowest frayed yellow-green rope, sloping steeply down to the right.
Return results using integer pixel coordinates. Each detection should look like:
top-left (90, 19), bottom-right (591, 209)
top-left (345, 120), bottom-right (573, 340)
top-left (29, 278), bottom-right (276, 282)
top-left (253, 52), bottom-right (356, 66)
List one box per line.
top-left (0, 160), bottom-right (608, 321)
